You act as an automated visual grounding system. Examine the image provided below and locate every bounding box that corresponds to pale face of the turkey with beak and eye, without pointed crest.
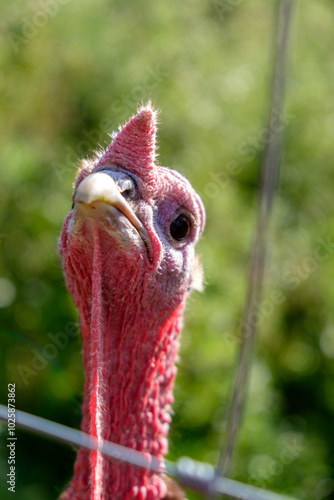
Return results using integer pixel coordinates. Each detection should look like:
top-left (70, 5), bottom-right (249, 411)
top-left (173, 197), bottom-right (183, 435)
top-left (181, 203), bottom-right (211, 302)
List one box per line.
top-left (68, 165), bottom-right (205, 306)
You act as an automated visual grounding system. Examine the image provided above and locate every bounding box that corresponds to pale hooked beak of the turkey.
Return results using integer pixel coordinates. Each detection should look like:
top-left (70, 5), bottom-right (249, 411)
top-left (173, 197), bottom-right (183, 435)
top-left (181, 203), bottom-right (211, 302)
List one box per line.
top-left (73, 172), bottom-right (145, 234)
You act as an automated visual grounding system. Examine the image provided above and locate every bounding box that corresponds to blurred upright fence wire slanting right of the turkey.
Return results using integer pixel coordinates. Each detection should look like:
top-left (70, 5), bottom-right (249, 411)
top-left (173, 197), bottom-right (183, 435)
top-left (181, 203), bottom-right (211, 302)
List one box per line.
top-left (217, 0), bottom-right (294, 475)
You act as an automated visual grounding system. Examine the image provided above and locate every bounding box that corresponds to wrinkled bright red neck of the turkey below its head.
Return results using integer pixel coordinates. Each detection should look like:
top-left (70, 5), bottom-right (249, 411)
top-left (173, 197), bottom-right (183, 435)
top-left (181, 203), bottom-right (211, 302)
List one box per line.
top-left (61, 222), bottom-right (185, 500)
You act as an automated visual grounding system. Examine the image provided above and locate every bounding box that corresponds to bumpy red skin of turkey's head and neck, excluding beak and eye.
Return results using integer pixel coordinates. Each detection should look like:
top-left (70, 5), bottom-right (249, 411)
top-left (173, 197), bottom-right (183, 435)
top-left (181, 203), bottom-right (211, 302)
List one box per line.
top-left (59, 106), bottom-right (205, 500)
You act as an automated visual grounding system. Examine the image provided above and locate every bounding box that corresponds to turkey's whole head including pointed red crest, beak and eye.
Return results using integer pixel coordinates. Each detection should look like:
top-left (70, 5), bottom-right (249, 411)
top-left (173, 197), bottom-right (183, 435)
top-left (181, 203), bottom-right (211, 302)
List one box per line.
top-left (60, 106), bottom-right (205, 311)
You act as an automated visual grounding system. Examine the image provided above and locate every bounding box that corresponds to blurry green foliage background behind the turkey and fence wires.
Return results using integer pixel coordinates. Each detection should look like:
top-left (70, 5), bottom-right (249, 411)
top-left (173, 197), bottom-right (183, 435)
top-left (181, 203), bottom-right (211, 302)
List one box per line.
top-left (0, 0), bottom-right (334, 500)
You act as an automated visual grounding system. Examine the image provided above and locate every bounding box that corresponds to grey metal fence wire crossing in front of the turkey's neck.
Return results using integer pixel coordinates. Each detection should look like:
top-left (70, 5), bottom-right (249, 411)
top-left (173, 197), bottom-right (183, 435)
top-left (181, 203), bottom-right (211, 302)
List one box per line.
top-left (0, 405), bottom-right (295, 500)
